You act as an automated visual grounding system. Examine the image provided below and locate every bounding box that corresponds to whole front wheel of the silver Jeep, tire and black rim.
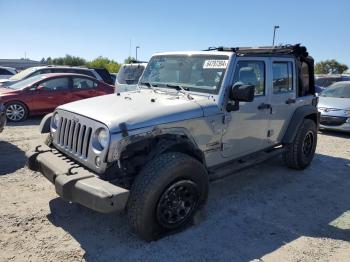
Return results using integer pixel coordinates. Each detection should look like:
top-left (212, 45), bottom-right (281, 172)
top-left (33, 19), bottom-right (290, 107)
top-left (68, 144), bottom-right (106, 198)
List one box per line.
top-left (127, 152), bottom-right (208, 241)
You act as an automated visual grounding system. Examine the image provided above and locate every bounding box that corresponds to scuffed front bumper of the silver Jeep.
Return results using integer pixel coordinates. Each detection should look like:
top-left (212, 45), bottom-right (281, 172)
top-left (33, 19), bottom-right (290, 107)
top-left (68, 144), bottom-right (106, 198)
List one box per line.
top-left (26, 144), bottom-right (129, 213)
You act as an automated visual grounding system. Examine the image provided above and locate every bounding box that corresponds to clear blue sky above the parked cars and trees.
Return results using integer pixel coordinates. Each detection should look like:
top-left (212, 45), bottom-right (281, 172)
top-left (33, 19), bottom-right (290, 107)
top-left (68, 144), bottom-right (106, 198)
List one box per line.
top-left (0, 0), bottom-right (350, 67)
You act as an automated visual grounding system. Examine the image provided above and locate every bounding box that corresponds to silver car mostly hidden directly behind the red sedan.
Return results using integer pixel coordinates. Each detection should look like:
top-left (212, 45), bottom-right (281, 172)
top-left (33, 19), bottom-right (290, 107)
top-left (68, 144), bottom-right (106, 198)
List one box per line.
top-left (0, 66), bottom-right (114, 87)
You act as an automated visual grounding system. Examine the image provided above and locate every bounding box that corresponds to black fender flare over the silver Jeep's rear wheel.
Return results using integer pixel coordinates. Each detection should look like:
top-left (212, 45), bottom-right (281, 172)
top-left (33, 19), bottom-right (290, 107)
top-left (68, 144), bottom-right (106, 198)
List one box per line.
top-left (282, 105), bottom-right (320, 144)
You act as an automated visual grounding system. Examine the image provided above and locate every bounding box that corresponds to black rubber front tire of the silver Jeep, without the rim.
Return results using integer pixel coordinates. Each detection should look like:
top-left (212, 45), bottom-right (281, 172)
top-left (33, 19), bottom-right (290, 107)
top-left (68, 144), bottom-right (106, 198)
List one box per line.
top-left (127, 152), bottom-right (209, 241)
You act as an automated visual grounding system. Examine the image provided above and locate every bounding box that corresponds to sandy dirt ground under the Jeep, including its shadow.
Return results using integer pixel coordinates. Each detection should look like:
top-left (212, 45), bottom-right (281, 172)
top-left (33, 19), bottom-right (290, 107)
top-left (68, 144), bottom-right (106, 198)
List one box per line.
top-left (0, 119), bottom-right (350, 261)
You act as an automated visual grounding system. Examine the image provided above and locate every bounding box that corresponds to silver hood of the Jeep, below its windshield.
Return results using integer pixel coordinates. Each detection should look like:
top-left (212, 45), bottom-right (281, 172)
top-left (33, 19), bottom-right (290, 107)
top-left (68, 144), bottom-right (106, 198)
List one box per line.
top-left (58, 89), bottom-right (213, 132)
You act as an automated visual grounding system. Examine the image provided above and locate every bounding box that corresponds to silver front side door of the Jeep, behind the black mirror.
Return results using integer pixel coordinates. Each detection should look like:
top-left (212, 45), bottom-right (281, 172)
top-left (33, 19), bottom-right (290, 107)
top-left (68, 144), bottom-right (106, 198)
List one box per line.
top-left (222, 57), bottom-right (271, 159)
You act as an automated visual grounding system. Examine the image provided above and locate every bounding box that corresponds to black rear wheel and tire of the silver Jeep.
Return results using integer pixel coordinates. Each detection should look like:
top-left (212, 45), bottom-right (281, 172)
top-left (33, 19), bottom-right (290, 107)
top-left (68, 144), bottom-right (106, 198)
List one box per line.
top-left (283, 119), bottom-right (317, 169)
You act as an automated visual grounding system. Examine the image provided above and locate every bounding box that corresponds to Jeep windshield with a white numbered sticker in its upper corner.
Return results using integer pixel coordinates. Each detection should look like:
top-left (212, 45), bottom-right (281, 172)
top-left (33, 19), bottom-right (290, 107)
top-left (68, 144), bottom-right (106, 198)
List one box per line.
top-left (140, 55), bottom-right (229, 94)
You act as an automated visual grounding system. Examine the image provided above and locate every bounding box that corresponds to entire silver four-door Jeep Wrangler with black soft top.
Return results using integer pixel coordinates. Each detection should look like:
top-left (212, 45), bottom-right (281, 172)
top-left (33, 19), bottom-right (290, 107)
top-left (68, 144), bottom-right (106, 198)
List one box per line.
top-left (27, 45), bottom-right (319, 241)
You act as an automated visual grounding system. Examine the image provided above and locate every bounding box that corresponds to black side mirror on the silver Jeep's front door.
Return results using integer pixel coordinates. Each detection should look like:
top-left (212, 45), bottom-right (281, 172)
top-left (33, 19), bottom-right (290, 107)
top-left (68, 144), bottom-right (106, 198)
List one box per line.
top-left (226, 84), bottom-right (255, 112)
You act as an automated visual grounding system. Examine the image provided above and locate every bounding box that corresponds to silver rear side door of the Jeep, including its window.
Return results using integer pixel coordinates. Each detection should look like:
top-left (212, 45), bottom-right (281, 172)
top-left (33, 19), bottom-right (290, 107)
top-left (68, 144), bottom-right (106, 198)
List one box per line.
top-left (268, 58), bottom-right (297, 144)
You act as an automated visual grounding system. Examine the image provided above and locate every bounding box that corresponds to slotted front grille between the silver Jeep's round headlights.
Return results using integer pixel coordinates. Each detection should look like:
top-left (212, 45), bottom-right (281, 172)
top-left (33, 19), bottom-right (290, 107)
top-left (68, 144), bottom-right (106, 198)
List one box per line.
top-left (57, 117), bottom-right (92, 158)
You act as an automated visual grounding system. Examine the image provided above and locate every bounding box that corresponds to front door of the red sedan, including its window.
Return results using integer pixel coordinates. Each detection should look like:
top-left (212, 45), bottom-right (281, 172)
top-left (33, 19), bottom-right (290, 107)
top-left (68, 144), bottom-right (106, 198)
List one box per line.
top-left (30, 77), bottom-right (71, 113)
